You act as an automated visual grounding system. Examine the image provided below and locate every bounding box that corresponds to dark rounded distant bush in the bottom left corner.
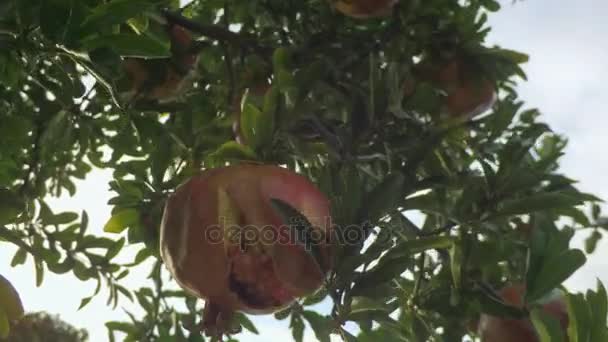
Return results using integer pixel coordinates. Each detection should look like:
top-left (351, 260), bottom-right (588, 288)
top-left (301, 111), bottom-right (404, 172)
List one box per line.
top-left (0, 312), bottom-right (88, 342)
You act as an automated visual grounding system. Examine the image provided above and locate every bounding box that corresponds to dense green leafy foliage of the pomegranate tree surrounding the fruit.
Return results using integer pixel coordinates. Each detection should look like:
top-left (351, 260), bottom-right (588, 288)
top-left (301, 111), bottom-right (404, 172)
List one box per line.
top-left (0, 0), bottom-right (608, 341)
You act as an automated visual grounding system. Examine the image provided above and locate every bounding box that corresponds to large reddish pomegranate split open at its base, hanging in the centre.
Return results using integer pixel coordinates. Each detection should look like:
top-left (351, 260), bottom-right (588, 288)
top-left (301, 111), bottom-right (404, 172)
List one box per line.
top-left (161, 164), bottom-right (331, 334)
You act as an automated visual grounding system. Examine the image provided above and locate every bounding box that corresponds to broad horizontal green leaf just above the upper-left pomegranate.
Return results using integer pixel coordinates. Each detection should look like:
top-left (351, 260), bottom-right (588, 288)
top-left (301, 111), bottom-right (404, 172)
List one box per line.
top-left (83, 33), bottom-right (171, 58)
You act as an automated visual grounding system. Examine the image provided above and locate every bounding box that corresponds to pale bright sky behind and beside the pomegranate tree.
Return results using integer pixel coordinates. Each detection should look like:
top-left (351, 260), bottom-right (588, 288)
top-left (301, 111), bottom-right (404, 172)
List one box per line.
top-left (0, 0), bottom-right (608, 342)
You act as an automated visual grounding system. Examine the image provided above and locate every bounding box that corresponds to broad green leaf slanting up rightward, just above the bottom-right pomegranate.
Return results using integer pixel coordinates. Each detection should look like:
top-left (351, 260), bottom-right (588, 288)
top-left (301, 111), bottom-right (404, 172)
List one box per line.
top-left (526, 249), bottom-right (587, 302)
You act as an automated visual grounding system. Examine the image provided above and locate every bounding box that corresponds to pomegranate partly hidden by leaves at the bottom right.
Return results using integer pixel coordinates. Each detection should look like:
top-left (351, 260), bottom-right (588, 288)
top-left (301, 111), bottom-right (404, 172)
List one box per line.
top-left (478, 285), bottom-right (568, 342)
